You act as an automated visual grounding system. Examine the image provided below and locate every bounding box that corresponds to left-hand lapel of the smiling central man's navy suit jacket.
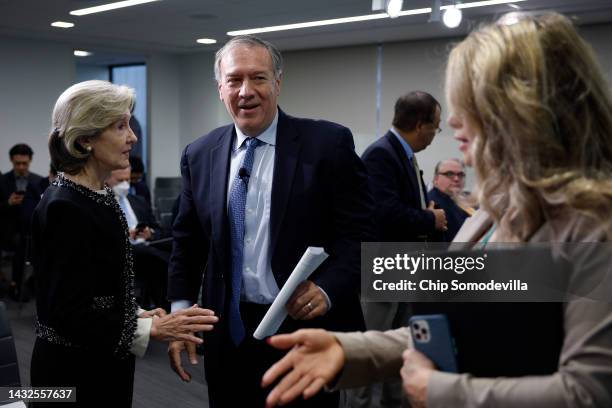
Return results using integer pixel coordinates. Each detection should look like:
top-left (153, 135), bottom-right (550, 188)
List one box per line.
top-left (208, 125), bottom-right (235, 249)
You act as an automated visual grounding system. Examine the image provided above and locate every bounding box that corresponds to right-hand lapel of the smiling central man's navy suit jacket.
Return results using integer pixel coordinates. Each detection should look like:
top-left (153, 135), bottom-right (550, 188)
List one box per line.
top-left (270, 108), bottom-right (301, 255)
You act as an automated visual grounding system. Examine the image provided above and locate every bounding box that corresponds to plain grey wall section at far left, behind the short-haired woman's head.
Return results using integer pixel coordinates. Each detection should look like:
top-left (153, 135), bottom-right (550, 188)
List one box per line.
top-left (0, 38), bottom-right (75, 175)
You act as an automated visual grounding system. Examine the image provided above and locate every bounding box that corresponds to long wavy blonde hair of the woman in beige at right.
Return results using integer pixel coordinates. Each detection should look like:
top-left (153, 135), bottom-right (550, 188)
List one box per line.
top-left (446, 13), bottom-right (612, 241)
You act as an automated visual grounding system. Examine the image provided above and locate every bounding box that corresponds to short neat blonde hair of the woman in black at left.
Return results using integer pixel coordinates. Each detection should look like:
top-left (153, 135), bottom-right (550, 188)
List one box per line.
top-left (49, 80), bottom-right (135, 174)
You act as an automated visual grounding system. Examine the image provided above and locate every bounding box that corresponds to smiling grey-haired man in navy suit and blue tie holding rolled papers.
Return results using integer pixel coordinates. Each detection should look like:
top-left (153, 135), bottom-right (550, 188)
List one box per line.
top-left (168, 36), bottom-right (372, 408)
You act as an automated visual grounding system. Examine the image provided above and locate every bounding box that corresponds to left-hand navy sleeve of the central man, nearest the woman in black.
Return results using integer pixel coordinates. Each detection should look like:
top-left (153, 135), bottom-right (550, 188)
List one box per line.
top-left (168, 146), bottom-right (209, 302)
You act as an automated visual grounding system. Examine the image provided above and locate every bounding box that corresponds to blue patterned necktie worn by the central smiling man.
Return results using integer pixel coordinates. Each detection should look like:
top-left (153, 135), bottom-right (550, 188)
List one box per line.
top-left (229, 137), bottom-right (259, 345)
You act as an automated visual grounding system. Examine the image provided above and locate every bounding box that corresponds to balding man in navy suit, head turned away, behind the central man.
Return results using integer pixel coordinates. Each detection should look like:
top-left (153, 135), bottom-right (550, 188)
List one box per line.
top-left (350, 91), bottom-right (446, 407)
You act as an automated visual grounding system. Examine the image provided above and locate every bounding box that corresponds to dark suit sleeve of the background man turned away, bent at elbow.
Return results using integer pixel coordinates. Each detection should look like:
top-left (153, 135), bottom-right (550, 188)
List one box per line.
top-left (364, 148), bottom-right (435, 236)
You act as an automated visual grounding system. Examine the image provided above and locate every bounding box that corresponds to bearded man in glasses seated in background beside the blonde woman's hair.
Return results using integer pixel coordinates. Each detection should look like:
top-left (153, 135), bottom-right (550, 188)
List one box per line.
top-left (428, 159), bottom-right (474, 242)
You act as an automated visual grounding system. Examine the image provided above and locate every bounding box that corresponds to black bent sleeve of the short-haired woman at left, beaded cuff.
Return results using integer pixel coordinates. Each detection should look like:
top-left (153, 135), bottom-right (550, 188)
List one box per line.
top-left (40, 201), bottom-right (136, 355)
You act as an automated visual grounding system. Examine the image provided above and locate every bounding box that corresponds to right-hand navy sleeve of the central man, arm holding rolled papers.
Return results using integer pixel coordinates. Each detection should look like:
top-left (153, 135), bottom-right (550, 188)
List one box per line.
top-left (312, 129), bottom-right (374, 306)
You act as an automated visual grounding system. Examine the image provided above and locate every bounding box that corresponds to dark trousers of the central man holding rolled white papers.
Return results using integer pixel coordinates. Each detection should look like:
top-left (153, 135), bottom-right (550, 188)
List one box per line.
top-left (204, 303), bottom-right (339, 408)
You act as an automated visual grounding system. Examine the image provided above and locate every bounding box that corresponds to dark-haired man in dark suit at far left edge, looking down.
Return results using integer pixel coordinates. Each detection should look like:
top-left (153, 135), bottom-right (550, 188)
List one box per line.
top-left (0, 143), bottom-right (44, 298)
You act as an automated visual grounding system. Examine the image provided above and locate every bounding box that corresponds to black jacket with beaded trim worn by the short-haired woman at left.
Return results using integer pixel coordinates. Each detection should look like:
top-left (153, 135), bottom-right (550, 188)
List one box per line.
top-left (32, 175), bottom-right (137, 358)
